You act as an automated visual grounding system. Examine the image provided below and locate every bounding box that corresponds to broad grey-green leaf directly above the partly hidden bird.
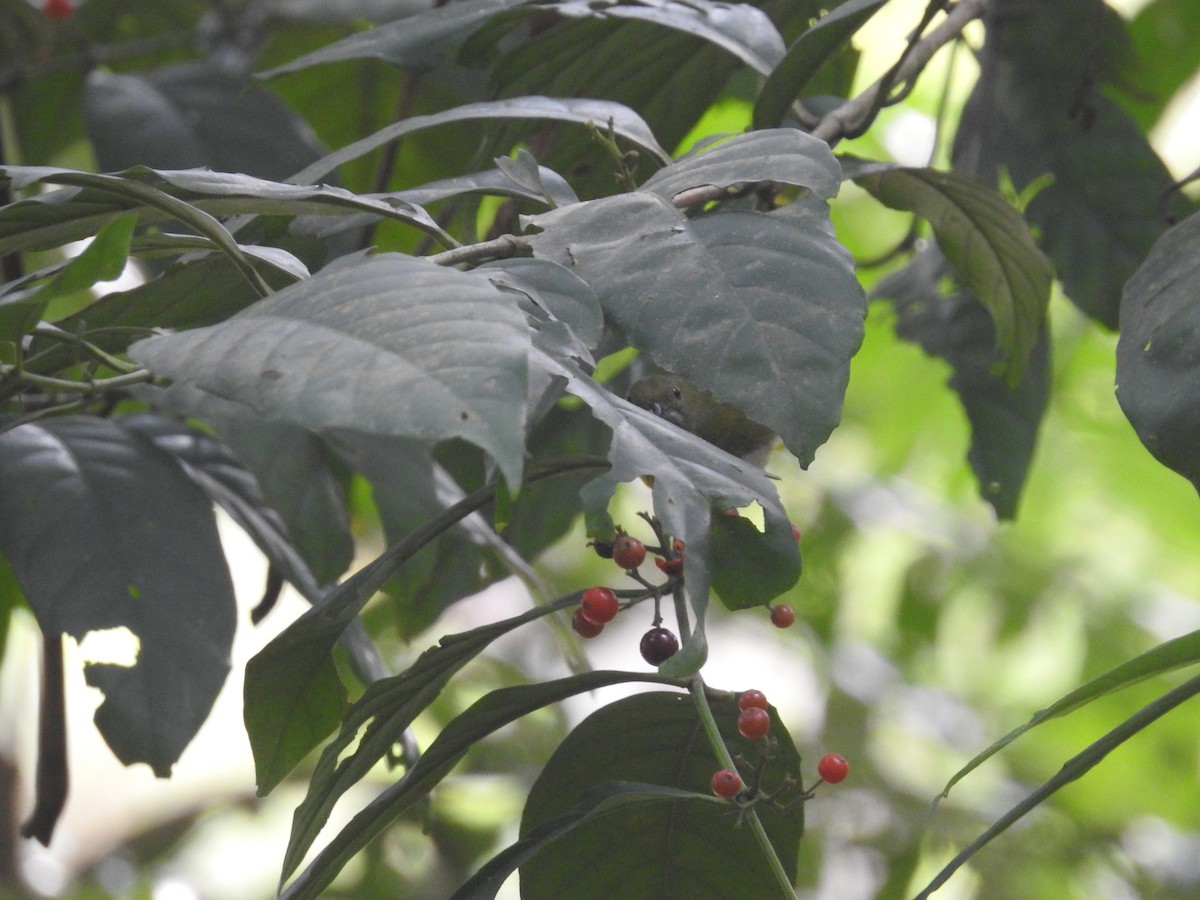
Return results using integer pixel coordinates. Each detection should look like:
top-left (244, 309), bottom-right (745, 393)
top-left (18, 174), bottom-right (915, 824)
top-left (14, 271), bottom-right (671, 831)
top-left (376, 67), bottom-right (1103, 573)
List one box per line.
top-left (529, 186), bottom-right (866, 464)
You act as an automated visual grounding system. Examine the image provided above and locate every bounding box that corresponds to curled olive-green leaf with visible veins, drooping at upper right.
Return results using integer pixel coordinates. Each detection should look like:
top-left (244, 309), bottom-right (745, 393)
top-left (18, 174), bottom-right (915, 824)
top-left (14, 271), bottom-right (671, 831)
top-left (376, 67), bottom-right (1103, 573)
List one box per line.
top-left (851, 166), bottom-right (1054, 386)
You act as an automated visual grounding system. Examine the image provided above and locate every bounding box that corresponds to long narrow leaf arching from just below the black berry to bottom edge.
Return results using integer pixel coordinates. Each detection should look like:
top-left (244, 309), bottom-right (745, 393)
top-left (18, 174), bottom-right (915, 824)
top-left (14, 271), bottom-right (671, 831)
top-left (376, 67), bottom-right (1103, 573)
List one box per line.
top-left (280, 672), bottom-right (679, 900)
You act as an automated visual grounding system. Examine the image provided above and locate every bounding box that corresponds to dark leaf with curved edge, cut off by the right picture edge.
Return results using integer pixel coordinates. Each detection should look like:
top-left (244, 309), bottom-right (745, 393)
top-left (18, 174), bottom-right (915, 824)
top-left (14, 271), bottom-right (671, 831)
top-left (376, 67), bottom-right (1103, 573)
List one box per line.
top-left (1117, 214), bottom-right (1200, 491)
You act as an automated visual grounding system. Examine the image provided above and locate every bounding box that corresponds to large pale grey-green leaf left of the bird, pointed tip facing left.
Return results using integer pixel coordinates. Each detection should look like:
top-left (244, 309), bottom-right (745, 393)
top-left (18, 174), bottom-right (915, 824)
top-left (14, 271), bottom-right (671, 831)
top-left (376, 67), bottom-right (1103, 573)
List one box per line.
top-left (130, 254), bottom-right (529, 485)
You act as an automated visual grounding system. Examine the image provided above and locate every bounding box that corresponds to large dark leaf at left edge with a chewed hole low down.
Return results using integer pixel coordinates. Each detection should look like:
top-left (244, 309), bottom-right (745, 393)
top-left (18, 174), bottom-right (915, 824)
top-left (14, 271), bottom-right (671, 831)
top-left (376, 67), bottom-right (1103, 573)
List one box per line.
top-left (0, 416), bottom-right (235, 778)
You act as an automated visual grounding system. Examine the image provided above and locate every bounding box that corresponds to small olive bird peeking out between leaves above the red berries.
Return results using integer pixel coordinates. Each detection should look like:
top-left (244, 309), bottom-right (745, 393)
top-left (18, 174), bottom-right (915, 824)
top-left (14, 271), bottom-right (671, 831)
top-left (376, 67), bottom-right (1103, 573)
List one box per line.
top-left (629, 374), bottom-right (778, 467)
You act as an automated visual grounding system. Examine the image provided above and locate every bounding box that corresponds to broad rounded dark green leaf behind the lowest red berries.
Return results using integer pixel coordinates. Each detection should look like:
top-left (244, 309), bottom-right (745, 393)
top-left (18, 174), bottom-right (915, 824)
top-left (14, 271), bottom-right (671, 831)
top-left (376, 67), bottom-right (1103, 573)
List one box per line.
top-left (521, 691), bottom-right (804, 900)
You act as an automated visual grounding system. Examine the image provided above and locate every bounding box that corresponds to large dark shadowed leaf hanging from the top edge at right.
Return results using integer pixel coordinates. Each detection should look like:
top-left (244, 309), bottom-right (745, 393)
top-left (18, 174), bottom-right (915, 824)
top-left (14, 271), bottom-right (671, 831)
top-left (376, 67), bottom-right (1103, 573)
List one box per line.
top-left (954, 0), bottom-right (1189, 328)
